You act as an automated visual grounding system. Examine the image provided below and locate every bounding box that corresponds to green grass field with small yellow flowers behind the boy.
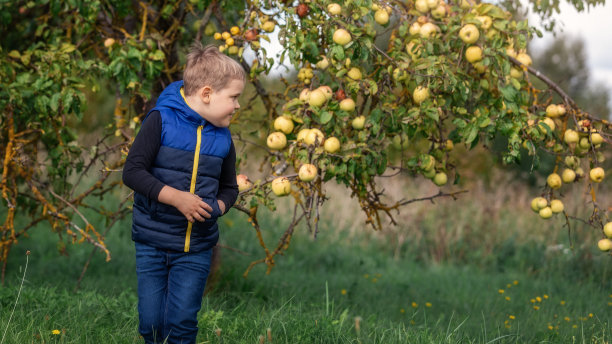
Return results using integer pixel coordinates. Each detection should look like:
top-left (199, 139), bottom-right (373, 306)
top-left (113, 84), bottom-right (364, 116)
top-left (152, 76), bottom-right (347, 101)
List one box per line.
top-left (0, 188), bottom-right (612, 344)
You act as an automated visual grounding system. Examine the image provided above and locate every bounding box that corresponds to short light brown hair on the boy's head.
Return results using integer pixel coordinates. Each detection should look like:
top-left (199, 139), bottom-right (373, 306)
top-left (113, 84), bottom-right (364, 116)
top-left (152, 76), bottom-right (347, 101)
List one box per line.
top-left (183, 42), bottom-right (246, 96)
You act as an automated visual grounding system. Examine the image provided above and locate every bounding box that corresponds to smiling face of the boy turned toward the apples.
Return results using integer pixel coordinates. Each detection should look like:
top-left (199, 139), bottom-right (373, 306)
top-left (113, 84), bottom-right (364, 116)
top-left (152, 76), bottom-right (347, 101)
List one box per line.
top-left (203, 79), bottom-right (244, 128)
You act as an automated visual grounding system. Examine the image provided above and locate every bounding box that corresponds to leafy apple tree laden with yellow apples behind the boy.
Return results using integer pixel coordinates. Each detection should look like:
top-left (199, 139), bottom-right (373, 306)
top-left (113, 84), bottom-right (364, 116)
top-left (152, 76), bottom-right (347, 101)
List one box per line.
top-left (0, 0), bottom-right (612, 275)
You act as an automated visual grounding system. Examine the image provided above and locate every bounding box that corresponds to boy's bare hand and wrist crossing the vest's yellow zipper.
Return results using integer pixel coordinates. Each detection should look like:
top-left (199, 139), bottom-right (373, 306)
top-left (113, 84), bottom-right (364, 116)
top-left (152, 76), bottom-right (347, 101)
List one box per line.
top-left (158, 185), bottom-right (212, 222)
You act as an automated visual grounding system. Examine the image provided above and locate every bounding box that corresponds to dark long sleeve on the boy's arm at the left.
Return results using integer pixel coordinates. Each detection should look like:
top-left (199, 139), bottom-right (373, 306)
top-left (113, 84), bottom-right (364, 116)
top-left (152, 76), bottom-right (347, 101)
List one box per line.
top-left (123, 111), bottom-right (164, 200)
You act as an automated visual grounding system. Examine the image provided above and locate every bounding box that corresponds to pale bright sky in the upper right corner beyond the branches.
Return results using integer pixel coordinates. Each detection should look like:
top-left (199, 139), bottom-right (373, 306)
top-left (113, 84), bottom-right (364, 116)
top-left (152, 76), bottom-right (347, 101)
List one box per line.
top-left (529, 0), bottom-right (612, 107)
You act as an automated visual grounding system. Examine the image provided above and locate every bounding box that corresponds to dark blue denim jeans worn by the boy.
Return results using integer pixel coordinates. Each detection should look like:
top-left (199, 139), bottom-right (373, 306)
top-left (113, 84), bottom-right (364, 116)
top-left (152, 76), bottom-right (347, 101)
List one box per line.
top-left (135, 242), bottom-right (212, 344)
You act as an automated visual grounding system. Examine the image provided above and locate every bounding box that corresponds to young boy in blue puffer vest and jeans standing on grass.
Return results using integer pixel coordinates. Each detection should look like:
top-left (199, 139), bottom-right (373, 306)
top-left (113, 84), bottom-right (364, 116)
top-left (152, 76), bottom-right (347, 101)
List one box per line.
top-left (123, 44), bottom-right (246, 343)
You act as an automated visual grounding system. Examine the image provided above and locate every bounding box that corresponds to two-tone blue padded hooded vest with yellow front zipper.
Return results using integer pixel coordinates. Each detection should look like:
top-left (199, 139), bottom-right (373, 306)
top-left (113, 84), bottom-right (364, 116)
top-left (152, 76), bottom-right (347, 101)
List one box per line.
top-left (132, 81), bottom-right (232, 252)
